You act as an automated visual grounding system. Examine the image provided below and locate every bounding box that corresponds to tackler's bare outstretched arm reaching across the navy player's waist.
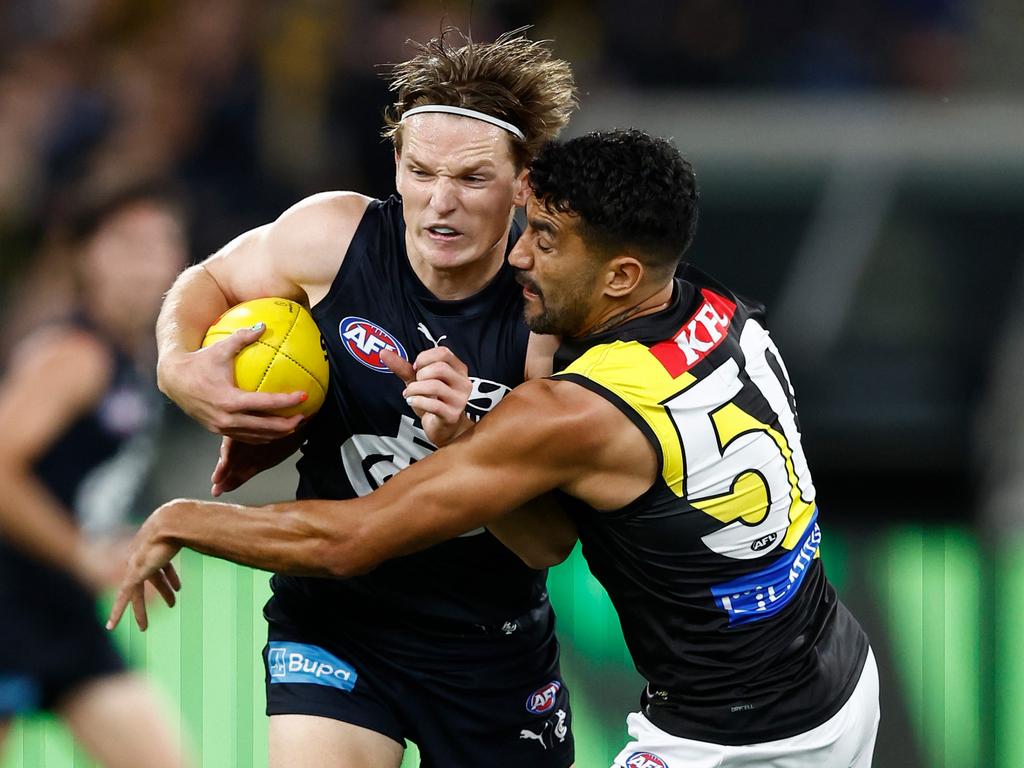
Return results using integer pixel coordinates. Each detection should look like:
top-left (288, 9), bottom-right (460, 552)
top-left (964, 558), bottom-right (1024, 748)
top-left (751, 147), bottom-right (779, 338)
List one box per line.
top-left (112, 380), bottom-right (656, 626)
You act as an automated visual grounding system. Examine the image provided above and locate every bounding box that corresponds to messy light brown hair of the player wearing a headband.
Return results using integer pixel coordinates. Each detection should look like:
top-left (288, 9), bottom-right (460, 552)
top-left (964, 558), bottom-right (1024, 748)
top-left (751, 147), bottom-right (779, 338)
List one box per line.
top-left (383, 27), bottom-right (578, 169)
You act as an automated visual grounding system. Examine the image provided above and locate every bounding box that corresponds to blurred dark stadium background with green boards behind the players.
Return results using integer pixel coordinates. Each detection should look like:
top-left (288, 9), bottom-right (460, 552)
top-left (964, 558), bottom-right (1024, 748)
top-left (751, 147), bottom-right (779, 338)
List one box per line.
top-left (0, 0), bottom-right (1024, 768)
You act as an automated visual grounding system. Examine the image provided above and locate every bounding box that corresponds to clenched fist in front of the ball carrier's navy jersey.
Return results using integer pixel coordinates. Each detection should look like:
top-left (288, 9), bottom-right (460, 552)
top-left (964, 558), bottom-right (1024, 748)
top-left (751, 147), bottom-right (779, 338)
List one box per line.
top-left (381, 347), bottom-right (473, 447)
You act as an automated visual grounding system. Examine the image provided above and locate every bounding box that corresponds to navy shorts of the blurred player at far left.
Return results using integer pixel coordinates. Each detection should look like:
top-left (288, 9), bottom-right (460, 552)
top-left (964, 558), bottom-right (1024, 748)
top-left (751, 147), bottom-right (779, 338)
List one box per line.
top-left (0, 548), bottom-right (125, 720)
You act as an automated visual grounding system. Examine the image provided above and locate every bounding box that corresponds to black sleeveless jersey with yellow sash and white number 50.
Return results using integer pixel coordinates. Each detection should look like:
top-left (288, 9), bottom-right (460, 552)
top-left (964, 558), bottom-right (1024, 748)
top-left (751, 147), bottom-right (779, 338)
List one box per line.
top-left (555, 266), bottom-right (867, 743)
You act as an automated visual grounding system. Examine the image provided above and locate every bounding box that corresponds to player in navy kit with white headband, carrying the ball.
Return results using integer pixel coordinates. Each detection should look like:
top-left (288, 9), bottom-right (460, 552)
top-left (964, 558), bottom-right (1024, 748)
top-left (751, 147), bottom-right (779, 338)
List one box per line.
top-left (158, 31), bottom-right (575, 768)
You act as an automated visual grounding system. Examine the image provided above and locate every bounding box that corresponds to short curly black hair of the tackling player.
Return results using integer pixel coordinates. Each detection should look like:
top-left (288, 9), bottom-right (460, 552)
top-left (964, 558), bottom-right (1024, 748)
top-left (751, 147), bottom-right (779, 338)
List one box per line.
top-left (529, 128), bottom-right (697, 275)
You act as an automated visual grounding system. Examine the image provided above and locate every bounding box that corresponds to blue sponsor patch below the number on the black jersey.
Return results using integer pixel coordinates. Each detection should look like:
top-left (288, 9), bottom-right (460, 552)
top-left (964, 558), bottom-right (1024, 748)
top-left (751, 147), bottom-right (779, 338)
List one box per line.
top-left (711, 510), bottom-right (821, 626)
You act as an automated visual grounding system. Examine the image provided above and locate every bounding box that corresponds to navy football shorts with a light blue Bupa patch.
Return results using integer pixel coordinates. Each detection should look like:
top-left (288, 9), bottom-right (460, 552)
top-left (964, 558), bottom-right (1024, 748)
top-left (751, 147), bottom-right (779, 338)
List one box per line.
top-left (263, 597), bottom-right (574, 768)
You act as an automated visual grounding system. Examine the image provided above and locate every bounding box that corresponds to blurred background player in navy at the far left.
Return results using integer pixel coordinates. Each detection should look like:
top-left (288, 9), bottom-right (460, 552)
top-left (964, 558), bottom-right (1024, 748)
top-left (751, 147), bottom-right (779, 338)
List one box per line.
top-left (0, 185), bottom-right (187, 768)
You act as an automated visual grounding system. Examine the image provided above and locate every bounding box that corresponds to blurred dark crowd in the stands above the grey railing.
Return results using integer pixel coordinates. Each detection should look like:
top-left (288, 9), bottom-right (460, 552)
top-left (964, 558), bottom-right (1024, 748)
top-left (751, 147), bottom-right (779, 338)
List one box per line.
top-left (0, 0), bottom-right (999, 355)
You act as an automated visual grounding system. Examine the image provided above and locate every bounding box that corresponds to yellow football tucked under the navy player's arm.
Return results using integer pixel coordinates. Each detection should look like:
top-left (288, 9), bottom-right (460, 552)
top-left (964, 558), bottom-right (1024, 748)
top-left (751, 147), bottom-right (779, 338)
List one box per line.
top-left (203, 298), bottom-right (328, 417)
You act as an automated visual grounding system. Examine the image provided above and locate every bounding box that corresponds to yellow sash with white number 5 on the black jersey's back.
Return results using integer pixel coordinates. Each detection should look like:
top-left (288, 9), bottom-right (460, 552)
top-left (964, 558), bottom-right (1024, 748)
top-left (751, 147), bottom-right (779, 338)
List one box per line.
top-left (563, 327), bottom-right (815, 558)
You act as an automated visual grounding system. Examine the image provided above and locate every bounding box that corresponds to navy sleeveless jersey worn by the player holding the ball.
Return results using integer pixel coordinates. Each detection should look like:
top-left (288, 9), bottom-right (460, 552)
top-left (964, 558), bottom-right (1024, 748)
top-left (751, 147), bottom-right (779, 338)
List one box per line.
top-left (272, 198), bottom-right (546, 627)
